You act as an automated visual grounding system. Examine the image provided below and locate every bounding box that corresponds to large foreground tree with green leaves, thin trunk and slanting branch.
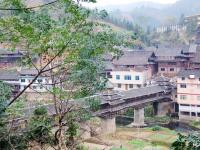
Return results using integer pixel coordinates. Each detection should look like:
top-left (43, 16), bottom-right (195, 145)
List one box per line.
top-left (0, 0), bottom-right (121, 150)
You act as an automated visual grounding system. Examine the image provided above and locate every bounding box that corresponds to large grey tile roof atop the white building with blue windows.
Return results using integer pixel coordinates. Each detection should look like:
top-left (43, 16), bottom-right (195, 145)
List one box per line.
top-left (113, 50), bottom-right (153, 66)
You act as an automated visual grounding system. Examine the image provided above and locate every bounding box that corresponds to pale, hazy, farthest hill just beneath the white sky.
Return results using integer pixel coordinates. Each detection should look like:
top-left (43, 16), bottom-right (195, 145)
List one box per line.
top-left (103, 0), bottom-right (200, 27)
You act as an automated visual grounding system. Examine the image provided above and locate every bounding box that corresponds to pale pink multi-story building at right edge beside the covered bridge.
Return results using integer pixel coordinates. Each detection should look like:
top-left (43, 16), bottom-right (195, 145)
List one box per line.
top-left (177, 69), bottom-right (200, 120)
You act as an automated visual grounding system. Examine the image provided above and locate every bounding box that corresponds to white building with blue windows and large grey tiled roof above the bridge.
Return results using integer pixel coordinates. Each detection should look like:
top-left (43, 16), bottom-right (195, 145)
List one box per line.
top-left (109, 50), bottom-right (156, 90)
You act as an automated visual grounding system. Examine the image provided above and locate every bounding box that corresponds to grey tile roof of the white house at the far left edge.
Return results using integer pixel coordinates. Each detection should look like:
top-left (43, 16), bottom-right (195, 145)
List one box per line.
top-left (0, 70), bottom-right (19, 81)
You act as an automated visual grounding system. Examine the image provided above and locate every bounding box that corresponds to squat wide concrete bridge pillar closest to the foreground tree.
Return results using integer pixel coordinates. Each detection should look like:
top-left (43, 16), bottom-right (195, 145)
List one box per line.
top-left (101, 117), bottom-right (116, 134)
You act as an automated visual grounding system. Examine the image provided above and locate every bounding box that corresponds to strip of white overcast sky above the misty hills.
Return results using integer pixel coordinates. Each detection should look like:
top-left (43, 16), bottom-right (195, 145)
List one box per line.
top-left (82, 0), bottom-right (177, 7)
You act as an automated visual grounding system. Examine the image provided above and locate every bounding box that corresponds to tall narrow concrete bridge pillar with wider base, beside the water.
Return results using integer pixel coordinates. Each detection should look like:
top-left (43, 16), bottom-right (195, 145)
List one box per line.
top-left (133, 108), bottom-right (145, 126)
